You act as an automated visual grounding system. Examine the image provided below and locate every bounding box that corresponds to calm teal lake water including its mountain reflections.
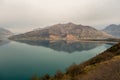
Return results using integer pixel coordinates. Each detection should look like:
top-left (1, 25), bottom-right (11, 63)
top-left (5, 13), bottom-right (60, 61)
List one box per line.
top-left (0, 41), bottom-right (112, 80)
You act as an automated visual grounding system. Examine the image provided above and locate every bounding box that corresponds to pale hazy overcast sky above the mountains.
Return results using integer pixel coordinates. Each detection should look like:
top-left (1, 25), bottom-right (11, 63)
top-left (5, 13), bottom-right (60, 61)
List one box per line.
top-left (0, 0), bottom-right (120, 33)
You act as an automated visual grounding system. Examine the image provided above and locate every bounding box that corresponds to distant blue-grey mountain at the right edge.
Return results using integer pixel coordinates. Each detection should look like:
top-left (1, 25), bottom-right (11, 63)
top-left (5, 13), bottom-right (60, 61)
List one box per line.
top-left (103, 24), bottom-right (120, 38)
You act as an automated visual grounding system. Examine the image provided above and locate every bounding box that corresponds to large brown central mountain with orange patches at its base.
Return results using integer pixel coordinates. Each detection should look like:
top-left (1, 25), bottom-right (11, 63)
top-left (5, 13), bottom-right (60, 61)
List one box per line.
top-left (11, 23), bottom-right (112, 40)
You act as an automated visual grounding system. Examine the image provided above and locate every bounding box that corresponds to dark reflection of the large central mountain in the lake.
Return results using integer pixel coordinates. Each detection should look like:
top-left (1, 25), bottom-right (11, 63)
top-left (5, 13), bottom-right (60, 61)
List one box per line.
top-left (15, 40), bottom-right (108, 53)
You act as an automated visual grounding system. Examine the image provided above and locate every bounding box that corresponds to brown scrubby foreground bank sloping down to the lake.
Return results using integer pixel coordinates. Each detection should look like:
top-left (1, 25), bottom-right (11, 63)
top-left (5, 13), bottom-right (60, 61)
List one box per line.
top-left (32, 43), bottom-right (120, 80)
